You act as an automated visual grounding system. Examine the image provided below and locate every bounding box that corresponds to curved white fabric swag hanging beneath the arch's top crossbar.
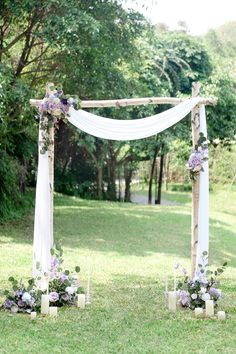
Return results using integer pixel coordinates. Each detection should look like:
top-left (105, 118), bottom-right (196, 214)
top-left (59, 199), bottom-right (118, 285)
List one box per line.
top-left (68, 97), bottom-right (199, 140)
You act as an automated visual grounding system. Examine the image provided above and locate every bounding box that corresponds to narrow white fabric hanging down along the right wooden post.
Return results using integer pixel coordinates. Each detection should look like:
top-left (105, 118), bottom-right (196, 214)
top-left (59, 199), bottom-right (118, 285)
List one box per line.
top-left (196, 105), bottom-right (209, 269)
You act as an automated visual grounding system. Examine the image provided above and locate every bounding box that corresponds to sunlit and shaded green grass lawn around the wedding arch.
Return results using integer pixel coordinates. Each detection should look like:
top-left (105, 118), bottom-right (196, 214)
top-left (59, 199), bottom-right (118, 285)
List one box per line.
top-left (0, 188), bottom-right (236, 354)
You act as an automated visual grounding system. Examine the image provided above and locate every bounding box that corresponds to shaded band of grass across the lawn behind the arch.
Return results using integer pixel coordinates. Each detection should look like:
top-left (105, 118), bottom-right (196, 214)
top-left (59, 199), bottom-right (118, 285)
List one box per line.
top-left (0, 195), bottom-right (236, 267)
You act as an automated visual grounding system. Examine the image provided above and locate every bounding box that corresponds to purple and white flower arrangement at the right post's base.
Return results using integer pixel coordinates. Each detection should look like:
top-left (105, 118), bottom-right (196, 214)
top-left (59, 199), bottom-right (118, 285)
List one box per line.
top-left (175, 252), bottom-right (227, 310)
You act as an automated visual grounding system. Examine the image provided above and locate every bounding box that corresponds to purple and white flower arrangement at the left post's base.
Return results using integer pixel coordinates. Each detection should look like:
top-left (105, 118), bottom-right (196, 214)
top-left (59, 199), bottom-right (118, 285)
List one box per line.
top-left (2, 244), bottom-right (84, 313)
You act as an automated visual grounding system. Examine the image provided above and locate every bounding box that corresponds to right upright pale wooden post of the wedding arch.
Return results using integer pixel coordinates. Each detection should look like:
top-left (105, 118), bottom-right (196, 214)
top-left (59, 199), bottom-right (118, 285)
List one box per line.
top-left (191, 82), bottom-right (200, 278)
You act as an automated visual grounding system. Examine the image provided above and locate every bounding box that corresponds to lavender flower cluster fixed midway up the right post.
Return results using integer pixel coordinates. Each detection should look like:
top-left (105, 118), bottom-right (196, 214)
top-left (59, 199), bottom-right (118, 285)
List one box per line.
top-left (186, 133), bottom-right (208, 180)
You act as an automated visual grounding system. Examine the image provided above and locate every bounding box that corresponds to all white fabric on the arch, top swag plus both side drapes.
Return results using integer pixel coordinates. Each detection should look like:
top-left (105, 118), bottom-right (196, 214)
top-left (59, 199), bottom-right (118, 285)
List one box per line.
top-left (33, 98), bottom-right (208, 275)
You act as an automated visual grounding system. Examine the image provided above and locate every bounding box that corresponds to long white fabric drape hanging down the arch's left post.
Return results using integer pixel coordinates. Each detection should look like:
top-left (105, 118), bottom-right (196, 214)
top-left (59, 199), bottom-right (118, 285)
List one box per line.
top-left (33, 120), bottom-right (53, 276)
